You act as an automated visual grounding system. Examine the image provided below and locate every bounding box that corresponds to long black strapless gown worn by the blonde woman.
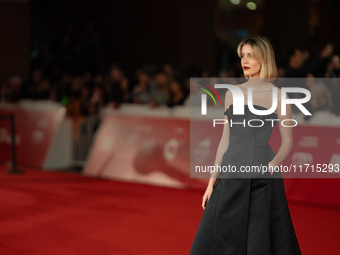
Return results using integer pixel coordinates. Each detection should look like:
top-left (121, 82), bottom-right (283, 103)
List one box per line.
top-left (189, 105), bottom-right (301, 255)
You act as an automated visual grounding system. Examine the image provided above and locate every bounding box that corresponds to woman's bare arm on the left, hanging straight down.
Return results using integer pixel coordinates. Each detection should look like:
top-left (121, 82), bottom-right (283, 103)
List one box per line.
top-left (202, 90), bottom-right (232, 209)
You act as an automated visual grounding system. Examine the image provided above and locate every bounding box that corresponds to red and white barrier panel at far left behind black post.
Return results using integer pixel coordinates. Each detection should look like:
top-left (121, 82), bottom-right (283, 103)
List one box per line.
top-left (0, 100), bottom-right (72, 169)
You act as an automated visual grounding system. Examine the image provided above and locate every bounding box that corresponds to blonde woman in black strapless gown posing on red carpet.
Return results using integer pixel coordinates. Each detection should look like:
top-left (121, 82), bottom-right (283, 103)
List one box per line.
top-left (189, 36), bottom-right (301, 255)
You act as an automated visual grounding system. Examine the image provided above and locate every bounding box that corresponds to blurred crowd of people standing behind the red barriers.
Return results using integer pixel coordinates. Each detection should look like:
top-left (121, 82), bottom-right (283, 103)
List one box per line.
top-left (0, 22), bottom-right (340, 117)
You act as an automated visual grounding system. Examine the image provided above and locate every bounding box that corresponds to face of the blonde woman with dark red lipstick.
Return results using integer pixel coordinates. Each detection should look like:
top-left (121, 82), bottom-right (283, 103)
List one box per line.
top-left (241, 44), bottom-right (261, 78)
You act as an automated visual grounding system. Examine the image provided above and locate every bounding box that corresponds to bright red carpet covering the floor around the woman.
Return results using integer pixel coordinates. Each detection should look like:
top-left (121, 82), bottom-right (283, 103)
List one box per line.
top-left (0, 167), bottom-right (340, 255)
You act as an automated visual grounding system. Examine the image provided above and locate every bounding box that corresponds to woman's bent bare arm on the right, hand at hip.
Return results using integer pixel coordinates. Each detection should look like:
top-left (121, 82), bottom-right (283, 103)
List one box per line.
top-left (269, 89), bottom-right (293, 175)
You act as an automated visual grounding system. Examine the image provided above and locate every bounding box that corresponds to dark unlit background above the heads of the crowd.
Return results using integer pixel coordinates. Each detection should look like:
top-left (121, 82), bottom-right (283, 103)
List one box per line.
top-left (0, 0), bottom-right (340, 79)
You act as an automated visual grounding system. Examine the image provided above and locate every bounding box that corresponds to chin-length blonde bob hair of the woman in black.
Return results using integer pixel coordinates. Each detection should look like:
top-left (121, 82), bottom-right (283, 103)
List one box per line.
top-left (237, 36), bottom-right (277, 79)
